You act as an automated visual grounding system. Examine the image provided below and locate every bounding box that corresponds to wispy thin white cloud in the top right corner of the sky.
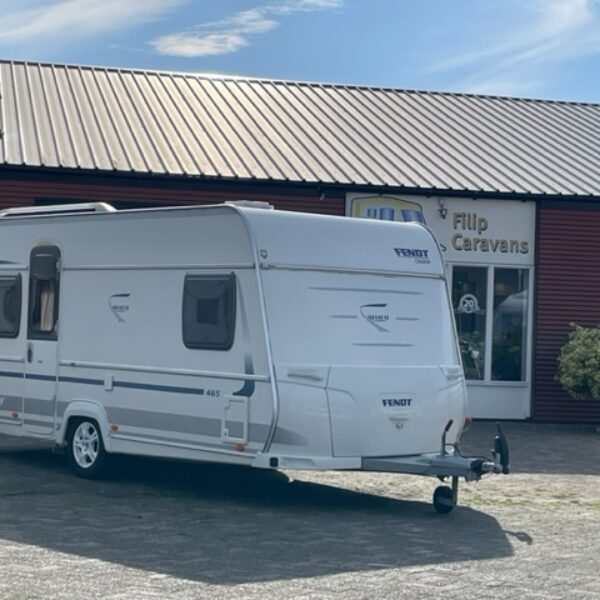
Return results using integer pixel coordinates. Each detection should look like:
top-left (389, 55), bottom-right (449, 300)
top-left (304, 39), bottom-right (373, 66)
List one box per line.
top-left (427, 0), bottom-right (600, 95)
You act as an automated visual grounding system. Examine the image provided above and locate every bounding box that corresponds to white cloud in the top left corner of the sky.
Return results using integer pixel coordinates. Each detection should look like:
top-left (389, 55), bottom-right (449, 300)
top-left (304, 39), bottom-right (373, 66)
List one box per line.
top-left (0, 0), bottom-right (187, 44)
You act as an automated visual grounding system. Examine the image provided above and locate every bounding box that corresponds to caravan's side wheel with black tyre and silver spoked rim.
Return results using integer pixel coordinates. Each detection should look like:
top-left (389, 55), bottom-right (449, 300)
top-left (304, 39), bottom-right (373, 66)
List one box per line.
top-left (67, 419), bottom-right (108, 479)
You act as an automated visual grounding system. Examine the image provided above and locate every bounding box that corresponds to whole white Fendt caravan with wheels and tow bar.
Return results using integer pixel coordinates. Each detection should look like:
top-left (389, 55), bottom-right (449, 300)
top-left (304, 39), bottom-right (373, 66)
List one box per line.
top-left (0, 203), bottom-right (508, 512)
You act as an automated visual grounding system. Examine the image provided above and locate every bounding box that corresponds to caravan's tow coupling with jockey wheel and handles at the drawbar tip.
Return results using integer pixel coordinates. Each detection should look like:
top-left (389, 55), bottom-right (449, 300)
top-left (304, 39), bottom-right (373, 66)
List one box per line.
top-left (432, 420), bottom-right (510, 514)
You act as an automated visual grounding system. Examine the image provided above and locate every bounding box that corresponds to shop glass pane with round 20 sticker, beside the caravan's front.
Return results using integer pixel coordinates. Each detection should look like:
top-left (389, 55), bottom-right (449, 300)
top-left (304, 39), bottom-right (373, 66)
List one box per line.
top-left (452, 266), bottom-right (488, 380)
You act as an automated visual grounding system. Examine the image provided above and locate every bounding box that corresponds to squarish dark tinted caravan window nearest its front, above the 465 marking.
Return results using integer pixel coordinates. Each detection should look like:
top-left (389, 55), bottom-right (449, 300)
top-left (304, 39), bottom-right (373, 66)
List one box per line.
top-left (182, 273), bottom-right (236, 350)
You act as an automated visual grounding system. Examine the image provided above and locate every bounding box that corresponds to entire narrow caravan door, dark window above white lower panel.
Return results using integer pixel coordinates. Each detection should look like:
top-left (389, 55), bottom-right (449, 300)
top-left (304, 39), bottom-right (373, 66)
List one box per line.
top-left (23, 246), bottom-right (60, 435)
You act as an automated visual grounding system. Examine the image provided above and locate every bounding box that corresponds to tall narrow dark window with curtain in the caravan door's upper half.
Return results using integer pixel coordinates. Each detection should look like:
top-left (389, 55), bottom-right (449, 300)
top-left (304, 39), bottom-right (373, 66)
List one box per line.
top-left (27, 246), bottom-right (60, 340)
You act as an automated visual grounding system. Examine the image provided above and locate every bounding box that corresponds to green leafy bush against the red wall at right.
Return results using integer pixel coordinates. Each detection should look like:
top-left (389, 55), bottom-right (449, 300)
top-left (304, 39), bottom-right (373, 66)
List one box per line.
top-left (556, 323), bottom-right (600, 400)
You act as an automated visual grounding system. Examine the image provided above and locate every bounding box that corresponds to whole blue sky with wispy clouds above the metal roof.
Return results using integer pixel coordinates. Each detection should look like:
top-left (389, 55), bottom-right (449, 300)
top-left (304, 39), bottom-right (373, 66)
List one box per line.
top-left (0, 0), bottom-right (600, 102)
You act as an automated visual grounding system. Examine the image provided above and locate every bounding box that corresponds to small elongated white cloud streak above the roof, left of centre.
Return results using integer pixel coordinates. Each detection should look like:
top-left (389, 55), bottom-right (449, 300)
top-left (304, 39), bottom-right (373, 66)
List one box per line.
top-left (151, 0), bottom-right (344, 58)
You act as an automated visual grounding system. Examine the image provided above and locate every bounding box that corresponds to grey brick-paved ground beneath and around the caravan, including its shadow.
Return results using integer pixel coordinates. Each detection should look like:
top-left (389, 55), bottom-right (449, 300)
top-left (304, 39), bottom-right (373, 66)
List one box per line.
top-left (0, 423), bottom-right (600, 600)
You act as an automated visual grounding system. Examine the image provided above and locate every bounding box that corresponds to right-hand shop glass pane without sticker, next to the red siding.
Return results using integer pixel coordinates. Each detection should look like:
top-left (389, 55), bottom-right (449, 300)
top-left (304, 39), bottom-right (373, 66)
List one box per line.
top-left (492, 268), bottom-right (529, 381)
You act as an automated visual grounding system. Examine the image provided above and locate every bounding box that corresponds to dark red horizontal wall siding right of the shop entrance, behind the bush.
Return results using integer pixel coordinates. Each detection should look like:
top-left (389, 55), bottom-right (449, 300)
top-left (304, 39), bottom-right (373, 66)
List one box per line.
top-left (533, 207), bottom-right (600, 423)
